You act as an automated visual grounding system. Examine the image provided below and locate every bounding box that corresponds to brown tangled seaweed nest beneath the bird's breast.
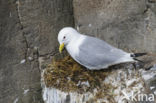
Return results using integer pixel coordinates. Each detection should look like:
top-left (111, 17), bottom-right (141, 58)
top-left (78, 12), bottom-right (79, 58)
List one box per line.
top-left (43, 56), bottom-right (112, 93)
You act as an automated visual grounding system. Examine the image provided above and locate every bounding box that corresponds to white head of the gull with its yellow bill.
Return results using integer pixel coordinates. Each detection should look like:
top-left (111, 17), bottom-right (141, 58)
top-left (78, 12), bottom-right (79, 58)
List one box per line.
top-left (58, 27), bottom-right (78, 53)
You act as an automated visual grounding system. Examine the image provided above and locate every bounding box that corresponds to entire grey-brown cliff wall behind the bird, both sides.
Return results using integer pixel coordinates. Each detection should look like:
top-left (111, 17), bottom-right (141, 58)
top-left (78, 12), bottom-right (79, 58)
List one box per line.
top-left (0, 0), bottom-right (156, 103)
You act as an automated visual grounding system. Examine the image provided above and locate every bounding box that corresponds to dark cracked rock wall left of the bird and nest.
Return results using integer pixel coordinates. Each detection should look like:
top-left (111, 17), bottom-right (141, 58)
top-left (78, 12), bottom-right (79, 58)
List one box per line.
top-left (0, 0), bottom-right (73, 103)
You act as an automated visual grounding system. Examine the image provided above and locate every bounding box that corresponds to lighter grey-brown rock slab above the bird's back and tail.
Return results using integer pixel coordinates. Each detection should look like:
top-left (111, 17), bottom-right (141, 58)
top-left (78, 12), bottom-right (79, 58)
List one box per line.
top-left (73, 0), bottom-right (156, 52)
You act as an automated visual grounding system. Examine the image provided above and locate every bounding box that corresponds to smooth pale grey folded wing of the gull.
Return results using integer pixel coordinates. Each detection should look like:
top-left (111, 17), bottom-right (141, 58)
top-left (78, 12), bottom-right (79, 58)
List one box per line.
top-left (76, 36), bottom-right (126, 68)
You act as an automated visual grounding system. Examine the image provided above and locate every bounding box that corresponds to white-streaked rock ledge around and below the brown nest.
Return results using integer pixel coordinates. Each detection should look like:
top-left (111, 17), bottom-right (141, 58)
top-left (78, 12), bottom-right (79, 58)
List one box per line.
top-left (42, 64), bottom-right (155, 103)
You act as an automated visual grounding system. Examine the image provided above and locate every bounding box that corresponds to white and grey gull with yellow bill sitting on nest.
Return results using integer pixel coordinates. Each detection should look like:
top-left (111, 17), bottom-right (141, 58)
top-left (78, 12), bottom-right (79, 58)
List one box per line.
top-left (58, 27), bottom-right (146, 70)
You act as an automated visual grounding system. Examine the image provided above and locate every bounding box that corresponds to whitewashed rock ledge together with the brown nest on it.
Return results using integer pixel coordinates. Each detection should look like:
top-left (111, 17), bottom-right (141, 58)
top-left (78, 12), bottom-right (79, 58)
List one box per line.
top-left (42, 56), bottom-right (153, 103)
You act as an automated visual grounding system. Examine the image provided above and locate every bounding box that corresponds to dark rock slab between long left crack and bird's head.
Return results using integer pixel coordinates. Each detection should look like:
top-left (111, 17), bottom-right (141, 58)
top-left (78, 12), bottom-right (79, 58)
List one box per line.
top-left (17, 0), bottom-right (74, 55)
